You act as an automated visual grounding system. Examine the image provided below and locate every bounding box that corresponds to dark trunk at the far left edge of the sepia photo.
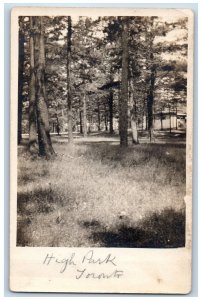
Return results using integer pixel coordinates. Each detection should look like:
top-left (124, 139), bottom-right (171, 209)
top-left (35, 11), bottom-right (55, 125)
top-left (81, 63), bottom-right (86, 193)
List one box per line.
top-left (18, 21), bottom-right (25, 144)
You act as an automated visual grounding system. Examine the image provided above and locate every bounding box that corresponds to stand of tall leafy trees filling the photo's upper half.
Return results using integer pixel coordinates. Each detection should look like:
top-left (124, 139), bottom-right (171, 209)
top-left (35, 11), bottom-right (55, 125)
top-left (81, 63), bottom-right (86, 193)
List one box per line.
top-left (18, 16), bottom-right (187, 158)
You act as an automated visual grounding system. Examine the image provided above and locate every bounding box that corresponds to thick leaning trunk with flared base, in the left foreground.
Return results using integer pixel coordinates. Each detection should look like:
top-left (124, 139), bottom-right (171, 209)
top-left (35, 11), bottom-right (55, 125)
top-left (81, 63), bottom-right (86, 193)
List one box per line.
top-left (34, 17), bottom-right (55, 158)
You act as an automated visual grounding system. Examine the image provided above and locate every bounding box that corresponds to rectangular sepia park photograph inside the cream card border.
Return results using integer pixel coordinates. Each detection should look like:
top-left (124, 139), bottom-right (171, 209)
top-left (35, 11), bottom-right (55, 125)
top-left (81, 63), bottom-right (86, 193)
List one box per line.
top-left (17, 12), bottom-right (187, 248)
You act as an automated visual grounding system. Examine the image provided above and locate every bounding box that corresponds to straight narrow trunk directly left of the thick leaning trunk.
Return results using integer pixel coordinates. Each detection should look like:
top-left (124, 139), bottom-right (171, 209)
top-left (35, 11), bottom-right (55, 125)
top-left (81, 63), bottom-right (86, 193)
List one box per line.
top-left (29, 17), bottom-right (38, 154)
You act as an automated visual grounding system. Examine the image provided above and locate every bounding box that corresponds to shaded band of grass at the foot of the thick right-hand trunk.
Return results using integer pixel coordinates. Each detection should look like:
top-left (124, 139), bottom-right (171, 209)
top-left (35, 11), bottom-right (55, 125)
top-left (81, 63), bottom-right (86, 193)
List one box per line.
top-left (78, 142), bottom-right (186, 171)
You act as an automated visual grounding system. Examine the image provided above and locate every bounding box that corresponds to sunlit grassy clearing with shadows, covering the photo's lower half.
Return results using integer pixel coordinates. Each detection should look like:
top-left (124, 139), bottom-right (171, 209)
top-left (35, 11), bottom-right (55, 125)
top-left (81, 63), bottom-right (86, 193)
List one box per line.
top-left (17, 132), bottom-right (186, 248)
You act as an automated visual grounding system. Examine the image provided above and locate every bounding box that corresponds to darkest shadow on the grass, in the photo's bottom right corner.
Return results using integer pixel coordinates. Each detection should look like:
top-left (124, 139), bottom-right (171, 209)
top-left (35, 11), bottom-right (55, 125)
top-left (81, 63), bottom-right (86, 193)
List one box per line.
top-left (83, 209), bottom-right (185, 248)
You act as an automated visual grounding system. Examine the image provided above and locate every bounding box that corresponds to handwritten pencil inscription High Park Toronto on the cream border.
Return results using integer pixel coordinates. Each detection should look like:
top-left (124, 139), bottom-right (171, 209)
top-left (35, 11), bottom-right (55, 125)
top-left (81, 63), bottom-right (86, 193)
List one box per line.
top-left (43, 250), bottom-right (123, 279)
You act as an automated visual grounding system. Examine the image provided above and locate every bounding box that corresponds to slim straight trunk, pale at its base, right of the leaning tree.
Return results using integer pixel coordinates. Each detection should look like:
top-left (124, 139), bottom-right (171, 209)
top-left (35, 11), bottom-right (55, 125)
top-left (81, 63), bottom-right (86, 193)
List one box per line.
top-left (67, 16), bottom-right (73, 143)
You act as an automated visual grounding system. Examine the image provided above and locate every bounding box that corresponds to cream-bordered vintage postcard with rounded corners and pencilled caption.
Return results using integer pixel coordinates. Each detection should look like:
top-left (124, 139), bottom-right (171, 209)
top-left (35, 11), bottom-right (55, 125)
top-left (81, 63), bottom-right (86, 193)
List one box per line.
top-left (10, 7), bottom-right (194, 294)
